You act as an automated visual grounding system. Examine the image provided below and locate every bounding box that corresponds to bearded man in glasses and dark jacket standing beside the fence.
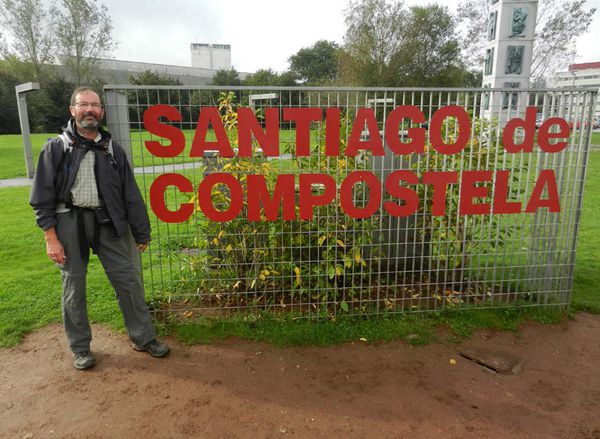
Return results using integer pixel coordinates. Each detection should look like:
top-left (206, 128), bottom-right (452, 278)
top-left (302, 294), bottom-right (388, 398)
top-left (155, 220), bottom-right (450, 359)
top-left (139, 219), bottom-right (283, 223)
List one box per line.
top-left (30, 87), bottom-right (169, 370)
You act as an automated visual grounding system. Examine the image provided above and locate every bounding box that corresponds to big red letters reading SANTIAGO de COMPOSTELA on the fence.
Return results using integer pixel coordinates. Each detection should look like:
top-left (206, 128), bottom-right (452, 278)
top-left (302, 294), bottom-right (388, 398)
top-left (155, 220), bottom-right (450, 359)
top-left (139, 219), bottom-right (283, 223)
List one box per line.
top-left (144, 104), bottom-right (570, 223)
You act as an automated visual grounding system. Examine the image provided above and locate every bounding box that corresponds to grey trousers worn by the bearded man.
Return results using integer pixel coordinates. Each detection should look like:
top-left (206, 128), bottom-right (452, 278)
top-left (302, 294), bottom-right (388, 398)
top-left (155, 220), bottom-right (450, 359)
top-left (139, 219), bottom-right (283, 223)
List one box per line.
top-left (56, 210), bottom-right (156, 352)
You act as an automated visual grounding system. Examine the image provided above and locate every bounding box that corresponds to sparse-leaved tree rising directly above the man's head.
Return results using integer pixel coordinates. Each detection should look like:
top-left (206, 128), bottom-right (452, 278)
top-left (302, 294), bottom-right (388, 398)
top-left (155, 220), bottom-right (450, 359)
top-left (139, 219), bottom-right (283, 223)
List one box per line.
top-left (53, 0), bottom-right (116, 84)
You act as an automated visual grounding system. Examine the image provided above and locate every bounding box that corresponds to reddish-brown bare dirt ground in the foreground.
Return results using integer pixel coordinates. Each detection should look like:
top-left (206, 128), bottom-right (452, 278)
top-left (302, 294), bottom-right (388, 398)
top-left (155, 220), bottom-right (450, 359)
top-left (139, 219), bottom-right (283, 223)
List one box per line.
top-left (0, 314), bottom-right (600, 439)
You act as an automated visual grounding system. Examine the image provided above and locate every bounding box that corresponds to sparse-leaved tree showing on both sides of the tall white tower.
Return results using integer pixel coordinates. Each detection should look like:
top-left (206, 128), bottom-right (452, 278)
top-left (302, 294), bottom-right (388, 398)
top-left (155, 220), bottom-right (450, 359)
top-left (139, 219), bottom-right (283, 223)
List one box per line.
top-left (458, 0), bottom-right (596, 84)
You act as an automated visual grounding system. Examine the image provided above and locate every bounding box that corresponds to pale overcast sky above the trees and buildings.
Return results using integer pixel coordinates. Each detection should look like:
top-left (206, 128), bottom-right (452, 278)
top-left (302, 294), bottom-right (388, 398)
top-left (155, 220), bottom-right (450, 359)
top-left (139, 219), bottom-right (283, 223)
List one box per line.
top-left (103, 0), bottom-right (600, 72)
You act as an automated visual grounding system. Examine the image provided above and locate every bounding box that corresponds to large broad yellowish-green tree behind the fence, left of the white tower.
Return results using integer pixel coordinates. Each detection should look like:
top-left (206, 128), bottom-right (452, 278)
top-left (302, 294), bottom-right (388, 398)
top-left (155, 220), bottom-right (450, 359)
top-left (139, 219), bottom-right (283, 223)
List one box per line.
top-left (340, 0), bottom-right (472, 87)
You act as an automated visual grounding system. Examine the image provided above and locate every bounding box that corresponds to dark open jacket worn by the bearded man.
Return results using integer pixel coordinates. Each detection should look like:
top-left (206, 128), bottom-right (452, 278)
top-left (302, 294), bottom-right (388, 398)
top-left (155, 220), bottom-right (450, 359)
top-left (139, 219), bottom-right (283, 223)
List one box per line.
top-left (29, 119), bottom-right (150, 244)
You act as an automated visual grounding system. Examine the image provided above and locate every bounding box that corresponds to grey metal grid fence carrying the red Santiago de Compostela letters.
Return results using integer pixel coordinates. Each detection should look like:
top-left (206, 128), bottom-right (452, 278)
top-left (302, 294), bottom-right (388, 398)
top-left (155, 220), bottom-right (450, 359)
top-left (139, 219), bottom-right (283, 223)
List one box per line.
top-left (105, 86), bottom-right (596, 317)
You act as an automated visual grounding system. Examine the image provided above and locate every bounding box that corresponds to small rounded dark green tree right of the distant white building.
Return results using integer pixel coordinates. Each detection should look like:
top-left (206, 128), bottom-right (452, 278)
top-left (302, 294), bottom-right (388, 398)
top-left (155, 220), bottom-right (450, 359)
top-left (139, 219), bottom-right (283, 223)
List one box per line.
top-left (289, 40), bottom-right (340, 85)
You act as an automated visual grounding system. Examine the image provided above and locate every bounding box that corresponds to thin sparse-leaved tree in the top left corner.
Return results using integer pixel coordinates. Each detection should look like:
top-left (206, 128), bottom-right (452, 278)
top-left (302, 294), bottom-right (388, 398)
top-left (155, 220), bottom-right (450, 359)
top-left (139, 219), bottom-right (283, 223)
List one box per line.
top-left (0, 0), bottom-right (54, 80)
